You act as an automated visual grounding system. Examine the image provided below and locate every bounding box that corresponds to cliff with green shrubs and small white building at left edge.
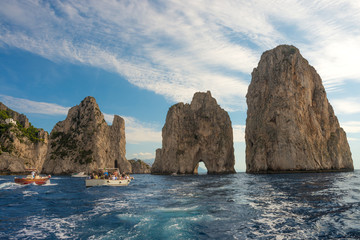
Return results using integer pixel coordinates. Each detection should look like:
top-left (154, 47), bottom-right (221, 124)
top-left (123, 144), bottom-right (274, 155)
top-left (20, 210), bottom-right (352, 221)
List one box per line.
top-left (0, 103), bottom-right (48, 173)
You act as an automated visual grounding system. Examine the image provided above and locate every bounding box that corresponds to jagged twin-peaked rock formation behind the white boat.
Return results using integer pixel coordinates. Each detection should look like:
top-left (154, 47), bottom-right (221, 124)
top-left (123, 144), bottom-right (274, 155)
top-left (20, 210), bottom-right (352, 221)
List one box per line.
top-left (43, 97), bottom-right (131, 174)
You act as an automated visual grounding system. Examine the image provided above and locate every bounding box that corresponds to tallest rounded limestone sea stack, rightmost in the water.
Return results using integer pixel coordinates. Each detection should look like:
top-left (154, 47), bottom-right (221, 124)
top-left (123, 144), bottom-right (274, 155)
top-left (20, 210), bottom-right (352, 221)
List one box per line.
top-left (245, 45), bottom-right (354, 173)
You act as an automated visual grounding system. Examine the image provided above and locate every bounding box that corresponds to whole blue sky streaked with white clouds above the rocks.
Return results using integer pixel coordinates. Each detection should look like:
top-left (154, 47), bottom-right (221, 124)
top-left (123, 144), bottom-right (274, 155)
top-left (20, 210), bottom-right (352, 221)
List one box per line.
top-left (0, 0), bottom-right (360, 171)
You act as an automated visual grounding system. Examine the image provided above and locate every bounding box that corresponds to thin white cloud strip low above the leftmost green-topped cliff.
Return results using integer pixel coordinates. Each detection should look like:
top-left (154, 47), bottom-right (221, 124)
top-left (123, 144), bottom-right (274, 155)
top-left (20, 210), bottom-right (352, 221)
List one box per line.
top-left (0, 94), bottom-right (70, 115)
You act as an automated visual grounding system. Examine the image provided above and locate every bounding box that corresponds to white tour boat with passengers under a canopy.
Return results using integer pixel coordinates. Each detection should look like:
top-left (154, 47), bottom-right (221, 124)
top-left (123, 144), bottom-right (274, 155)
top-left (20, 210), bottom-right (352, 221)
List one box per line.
top-left (85, 168), bottom-right (134, 187)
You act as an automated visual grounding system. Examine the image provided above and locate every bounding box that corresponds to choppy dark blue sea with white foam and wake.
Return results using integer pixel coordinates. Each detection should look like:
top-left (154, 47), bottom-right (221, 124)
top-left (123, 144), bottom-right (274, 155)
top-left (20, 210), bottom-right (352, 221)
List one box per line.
top-left (0, 171), bottom-right (360, 239)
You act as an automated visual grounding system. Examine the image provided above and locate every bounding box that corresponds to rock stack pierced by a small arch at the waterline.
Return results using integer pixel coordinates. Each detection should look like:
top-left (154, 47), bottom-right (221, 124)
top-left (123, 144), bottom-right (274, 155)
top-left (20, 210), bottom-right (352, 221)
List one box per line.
top-left (151, 92), bottom-right (235, 174)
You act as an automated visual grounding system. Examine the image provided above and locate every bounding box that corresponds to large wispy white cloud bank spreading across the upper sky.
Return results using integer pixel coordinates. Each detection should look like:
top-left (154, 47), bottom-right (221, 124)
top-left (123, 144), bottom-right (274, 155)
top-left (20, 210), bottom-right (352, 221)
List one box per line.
top-left (0, 0), bottom-right (360, 107)
